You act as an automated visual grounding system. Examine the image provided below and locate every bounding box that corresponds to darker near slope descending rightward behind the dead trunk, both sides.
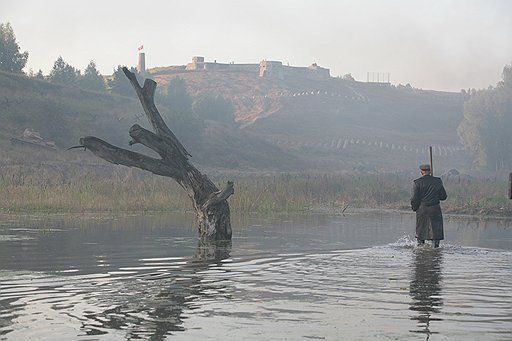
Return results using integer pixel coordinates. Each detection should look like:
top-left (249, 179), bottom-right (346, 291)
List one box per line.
top-left (0, 72), bottom-right (303, 170)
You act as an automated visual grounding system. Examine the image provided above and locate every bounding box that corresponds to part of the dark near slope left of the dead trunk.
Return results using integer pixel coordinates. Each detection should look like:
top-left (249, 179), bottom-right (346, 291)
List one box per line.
top-left (0, 72), bottom-right (140, 149)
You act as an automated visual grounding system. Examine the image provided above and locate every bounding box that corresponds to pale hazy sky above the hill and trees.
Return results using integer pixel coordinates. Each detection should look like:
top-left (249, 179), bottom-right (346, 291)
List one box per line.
top-left (0, 0), bottom-right (512, 91)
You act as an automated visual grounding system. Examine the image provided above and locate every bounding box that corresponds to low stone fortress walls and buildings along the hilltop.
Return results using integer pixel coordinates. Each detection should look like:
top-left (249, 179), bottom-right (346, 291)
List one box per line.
top-left (145, 56), bottom-right (331, 80)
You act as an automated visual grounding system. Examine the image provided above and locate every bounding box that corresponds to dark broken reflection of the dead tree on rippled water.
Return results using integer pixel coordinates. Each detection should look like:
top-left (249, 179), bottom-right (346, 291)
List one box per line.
top-left (80, 238), bottom-right (231, 340)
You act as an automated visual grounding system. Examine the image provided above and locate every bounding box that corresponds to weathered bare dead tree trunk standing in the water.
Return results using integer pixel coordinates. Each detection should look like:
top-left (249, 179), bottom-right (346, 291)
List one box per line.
top-left (80, 67), bottom-right (234, 240)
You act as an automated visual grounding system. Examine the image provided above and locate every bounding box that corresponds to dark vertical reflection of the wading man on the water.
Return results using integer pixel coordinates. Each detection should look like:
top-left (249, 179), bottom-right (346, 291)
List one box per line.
top-left (409, 247), bottom-right (443, 340)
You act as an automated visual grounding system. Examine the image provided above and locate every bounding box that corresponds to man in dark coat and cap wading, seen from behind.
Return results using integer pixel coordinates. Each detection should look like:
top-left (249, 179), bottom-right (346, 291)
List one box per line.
top-left (411, 165), bottom-right (447, 247)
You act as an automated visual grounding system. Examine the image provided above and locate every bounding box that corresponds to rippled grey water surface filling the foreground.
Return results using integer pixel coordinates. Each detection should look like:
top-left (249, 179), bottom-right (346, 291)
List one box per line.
top-left (0, 213), bottom-right (512, 340)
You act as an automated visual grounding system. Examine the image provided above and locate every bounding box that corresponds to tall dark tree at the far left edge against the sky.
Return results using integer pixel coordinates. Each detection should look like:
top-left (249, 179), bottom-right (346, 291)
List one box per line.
top-left (0, 23), bottom-right (28, 73)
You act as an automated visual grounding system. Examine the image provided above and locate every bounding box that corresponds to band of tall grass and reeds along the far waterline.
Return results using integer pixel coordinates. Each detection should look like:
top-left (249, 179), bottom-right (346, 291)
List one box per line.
top-left (0, 164), bottom-right (512, 217)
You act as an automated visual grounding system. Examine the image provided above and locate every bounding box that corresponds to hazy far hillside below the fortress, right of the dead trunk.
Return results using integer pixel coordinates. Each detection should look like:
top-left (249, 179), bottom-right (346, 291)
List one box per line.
top-left (149, 68), bottom-right (471, 171)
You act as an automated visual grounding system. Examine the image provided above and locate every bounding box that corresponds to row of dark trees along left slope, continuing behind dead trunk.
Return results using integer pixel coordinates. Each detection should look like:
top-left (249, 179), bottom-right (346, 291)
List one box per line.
top-left (0, 23), bottom-right (235, 129)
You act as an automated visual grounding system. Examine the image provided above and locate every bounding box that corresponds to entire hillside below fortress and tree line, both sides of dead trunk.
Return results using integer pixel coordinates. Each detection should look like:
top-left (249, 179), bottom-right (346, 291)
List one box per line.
top-left (0, 68), bottom-right (470, 172)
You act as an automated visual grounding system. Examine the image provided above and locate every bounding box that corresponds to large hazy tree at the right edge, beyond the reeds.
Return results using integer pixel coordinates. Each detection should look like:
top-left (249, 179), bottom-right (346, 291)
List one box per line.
top-left (457, 61), bottom-right (512, 170)
